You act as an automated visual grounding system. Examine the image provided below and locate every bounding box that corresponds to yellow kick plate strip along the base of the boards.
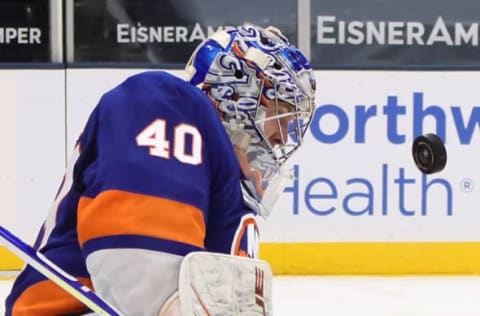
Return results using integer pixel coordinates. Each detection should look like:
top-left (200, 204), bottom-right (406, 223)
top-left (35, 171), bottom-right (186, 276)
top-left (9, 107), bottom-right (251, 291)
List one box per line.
top-left (0, 242), bottom-right (480, 275)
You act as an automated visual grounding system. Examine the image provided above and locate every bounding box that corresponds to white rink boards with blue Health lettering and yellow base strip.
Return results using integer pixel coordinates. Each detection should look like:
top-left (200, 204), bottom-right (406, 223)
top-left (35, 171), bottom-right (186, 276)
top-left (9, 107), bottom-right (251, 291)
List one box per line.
top-left (0, 69), bottom-right (480, 274)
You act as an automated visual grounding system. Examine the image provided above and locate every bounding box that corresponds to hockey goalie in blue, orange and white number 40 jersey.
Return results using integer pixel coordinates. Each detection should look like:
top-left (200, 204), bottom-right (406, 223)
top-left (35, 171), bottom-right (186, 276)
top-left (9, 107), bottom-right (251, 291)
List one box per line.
top-left (6, 24), bottom-right (315, 316)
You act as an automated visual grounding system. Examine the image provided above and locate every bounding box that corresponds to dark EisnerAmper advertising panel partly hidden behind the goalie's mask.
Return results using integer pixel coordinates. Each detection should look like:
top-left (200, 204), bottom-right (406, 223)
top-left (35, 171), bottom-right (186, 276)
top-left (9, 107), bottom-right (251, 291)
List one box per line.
top-left (69, 0), bottom-right (297, 66)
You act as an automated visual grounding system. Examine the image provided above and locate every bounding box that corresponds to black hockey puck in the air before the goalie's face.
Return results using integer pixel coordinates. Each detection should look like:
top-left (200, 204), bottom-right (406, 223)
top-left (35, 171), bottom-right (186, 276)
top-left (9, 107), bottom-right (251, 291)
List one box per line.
top-left (412, 134), bottom-right (447, 174)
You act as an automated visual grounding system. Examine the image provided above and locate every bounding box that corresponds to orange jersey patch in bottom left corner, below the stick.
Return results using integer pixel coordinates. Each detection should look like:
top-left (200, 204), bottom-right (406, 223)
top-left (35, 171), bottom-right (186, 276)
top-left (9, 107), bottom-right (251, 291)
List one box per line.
top-left (12, 278), bottom-right (93, 316)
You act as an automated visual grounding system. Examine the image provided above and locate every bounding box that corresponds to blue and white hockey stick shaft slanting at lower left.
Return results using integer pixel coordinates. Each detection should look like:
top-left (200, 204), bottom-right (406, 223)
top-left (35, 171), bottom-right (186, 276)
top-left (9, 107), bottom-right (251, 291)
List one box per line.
top-left (0, 226), bottom-right (122, 316)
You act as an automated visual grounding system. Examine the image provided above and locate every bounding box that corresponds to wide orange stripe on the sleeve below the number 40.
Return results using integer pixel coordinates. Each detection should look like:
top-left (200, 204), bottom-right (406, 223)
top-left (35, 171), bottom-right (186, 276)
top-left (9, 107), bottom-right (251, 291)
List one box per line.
top-left (78, 190), bottom-right (206, 248)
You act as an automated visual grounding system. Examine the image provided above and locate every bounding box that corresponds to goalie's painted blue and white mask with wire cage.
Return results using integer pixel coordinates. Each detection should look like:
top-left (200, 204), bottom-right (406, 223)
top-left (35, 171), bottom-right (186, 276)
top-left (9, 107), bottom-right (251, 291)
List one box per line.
top-left (186, 24), bottom-right (315, 217)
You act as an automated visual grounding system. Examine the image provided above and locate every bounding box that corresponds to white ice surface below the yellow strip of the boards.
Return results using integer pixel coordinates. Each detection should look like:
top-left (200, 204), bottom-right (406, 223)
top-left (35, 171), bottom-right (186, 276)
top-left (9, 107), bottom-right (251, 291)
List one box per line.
top-left (0, 276), bottom-right (480, 316)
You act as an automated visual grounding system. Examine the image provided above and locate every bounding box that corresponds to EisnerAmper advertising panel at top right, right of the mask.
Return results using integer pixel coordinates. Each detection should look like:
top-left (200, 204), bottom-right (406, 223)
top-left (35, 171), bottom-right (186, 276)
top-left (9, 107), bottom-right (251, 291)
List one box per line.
top-left (310, 0), bottom-right (480, 69)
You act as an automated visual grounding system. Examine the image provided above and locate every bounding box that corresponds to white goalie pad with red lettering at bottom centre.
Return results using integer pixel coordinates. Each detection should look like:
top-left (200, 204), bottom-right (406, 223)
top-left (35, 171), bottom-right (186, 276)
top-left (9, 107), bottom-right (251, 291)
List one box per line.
top-left (179, 252), bottom-right (272, 316)
